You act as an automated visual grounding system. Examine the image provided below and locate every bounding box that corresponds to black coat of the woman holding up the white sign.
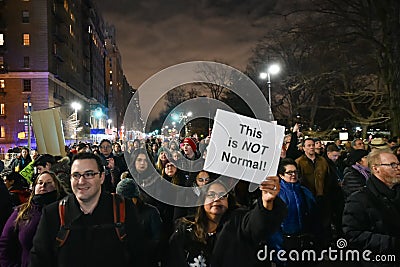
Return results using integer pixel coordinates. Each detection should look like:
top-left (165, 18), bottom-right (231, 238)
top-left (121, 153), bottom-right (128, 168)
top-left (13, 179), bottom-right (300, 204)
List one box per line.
top-left (167, 197), bottom-right (287, 267)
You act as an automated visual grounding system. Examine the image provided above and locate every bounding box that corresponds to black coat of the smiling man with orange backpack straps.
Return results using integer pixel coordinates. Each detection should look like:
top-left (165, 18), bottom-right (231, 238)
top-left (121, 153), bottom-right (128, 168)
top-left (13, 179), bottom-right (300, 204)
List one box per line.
top-left (30, 193), bottom-right (144, 267)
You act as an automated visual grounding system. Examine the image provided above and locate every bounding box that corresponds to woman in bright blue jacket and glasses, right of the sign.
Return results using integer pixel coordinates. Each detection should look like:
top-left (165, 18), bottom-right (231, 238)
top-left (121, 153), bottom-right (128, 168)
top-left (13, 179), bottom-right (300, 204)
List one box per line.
top-left (269, 158), bottom-right (318, 266)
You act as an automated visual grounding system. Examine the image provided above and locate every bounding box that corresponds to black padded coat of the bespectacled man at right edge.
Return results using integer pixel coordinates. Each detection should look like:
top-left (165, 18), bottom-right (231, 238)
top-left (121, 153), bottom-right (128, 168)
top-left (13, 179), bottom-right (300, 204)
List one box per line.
top-left (343, 176), bottom-right (400, 267)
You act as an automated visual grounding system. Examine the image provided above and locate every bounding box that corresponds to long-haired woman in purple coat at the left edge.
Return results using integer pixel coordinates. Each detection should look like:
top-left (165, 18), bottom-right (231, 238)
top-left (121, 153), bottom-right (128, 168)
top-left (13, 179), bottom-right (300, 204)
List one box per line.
top-left (0, 171), bottom-right (66, 267)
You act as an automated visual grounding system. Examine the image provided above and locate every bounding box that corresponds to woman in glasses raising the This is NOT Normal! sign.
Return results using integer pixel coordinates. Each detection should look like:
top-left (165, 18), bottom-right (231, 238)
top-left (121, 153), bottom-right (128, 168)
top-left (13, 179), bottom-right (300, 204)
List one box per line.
top-left (167, 177), bottom-right (286, 267)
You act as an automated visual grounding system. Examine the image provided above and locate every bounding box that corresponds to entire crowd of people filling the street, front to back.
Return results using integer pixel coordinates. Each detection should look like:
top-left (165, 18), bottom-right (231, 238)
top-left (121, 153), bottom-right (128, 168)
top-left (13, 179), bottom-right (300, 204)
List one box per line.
top-left (0, 124), bottom-right (400, 267)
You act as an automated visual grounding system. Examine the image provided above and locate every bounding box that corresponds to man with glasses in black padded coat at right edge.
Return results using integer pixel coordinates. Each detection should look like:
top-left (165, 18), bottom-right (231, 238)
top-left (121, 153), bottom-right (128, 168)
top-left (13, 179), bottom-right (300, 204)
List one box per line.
top-left (343, 149), bottom-right (400, 266)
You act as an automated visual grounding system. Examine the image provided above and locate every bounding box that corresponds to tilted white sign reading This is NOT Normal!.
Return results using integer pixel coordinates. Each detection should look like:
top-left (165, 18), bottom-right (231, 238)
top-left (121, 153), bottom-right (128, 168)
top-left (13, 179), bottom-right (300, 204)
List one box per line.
top-left (204, 109), bottom-right (285, 184)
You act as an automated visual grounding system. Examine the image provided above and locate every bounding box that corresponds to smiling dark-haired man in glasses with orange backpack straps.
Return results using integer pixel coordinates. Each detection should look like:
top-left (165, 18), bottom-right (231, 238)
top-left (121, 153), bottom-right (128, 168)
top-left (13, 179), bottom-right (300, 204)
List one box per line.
top-left (30, 153), bottom-right (145, 267)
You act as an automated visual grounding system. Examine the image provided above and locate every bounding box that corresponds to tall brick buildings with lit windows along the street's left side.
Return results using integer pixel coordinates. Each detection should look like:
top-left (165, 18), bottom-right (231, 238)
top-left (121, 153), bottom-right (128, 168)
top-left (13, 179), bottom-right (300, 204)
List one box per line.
top-left (0, 0), bottom-right (131, 152)
